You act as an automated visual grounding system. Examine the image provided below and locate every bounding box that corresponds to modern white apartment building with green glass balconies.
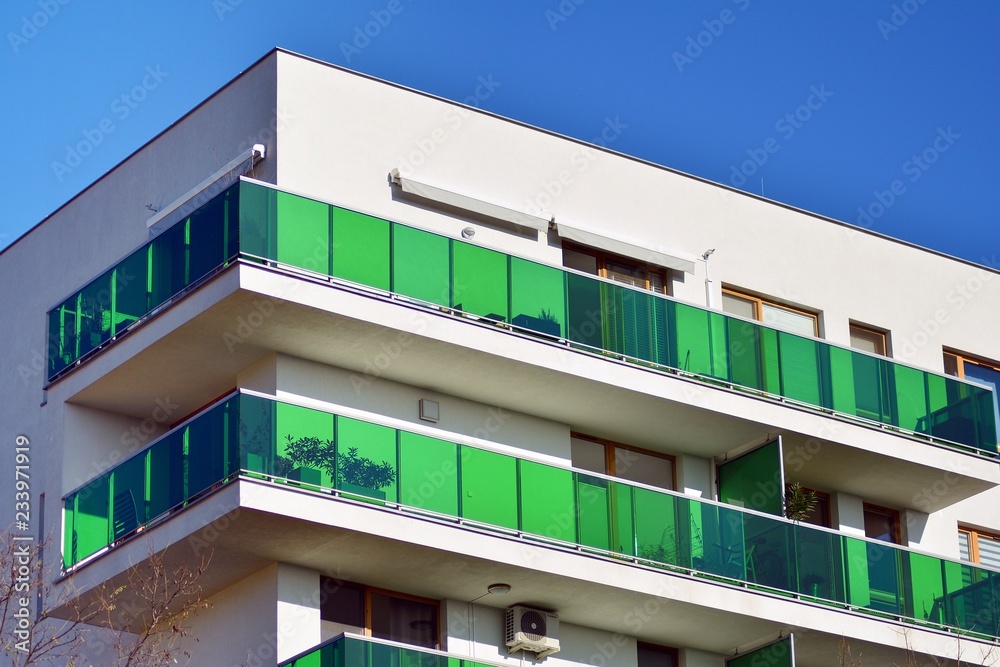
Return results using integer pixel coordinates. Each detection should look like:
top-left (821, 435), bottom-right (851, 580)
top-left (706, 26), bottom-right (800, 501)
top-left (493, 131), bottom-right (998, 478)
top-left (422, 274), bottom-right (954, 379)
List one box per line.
top-left (0, 49), bottom-right (1000, 667)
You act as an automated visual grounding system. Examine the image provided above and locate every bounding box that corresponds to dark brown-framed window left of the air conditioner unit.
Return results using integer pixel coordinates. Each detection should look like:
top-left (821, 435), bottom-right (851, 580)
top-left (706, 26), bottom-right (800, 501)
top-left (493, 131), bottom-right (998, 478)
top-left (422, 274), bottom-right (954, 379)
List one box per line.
top-left (320, 577), bottom-right (440, 649)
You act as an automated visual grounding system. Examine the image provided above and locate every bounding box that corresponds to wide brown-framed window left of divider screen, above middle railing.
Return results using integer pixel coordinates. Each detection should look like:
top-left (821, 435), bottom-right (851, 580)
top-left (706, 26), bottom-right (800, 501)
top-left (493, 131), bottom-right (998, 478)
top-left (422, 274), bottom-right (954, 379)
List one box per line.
top-left (570, 433), bottom-right (676, 489)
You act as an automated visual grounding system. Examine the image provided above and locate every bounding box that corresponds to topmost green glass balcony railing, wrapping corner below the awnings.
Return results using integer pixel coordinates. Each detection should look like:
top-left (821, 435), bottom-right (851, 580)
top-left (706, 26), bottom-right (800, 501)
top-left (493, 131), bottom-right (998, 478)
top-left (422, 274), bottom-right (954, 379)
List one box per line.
top-left (43, 181), bottom-right (997, 455)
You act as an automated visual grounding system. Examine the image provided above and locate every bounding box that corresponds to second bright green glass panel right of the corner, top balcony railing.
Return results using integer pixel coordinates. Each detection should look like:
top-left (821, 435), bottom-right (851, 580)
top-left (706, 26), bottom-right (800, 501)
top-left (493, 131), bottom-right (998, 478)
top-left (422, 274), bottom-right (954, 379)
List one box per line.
top-left (333, 208), bottom-right (390, 290)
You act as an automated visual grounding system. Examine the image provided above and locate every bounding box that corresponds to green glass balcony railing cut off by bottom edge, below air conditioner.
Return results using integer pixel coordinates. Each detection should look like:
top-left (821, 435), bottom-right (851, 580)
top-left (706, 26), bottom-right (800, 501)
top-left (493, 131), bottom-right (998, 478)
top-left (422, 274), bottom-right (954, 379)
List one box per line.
top-left (278, 634), bottom-right (498, 667)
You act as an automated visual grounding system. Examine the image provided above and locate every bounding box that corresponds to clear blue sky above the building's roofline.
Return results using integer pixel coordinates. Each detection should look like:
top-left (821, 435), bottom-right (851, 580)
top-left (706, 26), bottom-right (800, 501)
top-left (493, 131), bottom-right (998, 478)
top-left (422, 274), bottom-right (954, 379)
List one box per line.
top-left (0, 0), bottom-right (1000, 265)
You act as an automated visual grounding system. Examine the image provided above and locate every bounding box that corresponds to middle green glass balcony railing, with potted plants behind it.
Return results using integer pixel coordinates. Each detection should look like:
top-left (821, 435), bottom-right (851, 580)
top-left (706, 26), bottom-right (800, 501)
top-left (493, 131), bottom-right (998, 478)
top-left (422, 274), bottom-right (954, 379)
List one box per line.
top-left (63, 393), bottom-right (1000, 637)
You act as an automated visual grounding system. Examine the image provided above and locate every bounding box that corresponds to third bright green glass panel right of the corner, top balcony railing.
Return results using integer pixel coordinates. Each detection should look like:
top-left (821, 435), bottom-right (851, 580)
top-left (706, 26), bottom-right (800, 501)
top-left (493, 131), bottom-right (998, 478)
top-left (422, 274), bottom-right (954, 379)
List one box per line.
top-left (392, 224), bottom-right (451, 306)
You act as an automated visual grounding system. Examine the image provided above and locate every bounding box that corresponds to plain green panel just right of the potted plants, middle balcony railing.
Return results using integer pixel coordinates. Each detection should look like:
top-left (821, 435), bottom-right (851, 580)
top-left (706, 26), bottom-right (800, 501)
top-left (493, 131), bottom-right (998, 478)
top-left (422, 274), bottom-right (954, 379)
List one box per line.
top-left (399, 431), bottom-right (459, 516)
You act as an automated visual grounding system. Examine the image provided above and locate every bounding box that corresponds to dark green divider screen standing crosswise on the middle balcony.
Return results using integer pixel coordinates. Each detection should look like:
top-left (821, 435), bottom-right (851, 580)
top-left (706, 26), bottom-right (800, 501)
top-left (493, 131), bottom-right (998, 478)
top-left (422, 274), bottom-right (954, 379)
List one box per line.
top-left (718, 440), bottom-right (785, 516)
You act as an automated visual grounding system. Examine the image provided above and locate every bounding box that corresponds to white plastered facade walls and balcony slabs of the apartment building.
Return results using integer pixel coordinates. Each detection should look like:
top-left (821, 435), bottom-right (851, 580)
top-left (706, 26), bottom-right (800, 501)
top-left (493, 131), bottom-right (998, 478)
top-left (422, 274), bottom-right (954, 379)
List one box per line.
top-left (0, 50), bottom-right (1000, 667)
